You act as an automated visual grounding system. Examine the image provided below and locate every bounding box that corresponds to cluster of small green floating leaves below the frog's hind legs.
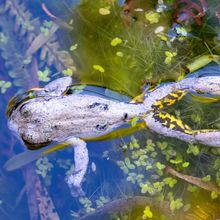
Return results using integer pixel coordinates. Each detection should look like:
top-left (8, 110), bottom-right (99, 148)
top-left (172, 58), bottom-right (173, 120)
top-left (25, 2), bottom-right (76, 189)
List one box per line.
top-left (99, 133), bottom-right (220, 215)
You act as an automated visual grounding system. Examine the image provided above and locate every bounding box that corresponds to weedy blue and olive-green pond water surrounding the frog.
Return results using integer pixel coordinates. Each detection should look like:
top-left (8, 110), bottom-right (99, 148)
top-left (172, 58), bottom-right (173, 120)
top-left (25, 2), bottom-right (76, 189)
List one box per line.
top-left (0, 0), bottom-right (220, 219)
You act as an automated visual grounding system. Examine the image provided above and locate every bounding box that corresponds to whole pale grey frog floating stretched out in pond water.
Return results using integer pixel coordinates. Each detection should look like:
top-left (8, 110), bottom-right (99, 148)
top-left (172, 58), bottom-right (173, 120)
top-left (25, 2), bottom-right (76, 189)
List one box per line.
top-left (7, 65), bottom-right (220, 197)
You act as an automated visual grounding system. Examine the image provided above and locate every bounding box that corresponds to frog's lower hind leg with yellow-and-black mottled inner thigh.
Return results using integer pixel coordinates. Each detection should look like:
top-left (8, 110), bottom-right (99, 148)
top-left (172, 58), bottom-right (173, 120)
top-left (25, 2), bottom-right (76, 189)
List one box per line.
top-left (144, 111), bottom-right (220, 147)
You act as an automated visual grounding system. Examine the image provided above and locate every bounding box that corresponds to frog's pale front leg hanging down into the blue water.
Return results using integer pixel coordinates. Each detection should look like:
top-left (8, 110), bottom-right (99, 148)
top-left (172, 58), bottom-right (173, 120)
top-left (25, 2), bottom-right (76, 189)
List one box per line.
top-left (66, 137), bottom-right (89, 197)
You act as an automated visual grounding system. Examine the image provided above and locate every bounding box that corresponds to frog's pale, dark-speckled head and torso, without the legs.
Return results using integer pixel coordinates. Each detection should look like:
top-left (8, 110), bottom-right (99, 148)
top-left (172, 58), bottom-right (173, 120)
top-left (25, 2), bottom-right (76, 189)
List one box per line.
top-left (9, 85), bottom-right (145, 148)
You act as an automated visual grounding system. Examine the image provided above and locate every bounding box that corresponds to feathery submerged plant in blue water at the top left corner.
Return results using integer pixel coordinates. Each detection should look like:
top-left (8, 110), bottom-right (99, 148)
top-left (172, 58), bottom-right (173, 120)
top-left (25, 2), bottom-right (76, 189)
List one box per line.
top-left (0, 0), bottom-right (75, 87)
